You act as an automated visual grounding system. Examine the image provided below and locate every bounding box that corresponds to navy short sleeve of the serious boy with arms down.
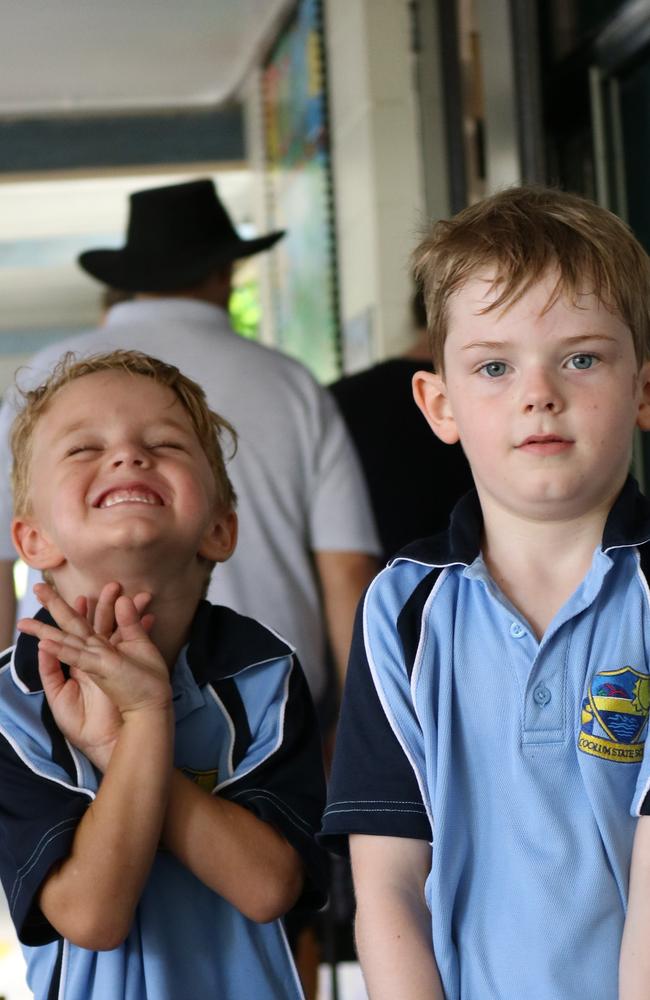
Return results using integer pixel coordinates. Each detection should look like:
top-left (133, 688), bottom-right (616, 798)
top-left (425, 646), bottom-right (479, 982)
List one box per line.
top-left (319, 603), bottom-right (431, 854)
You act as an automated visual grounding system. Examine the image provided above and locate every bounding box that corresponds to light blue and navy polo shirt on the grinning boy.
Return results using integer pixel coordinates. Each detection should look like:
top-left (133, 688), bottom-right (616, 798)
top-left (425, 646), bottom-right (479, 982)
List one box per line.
top-left (0, 602), bottom-right (325, 1000)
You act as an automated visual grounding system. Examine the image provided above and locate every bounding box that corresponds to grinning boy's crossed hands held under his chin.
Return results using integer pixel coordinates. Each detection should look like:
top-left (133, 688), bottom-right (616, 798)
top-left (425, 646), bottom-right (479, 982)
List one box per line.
top-left (18, 582), bottom-right (172, 772)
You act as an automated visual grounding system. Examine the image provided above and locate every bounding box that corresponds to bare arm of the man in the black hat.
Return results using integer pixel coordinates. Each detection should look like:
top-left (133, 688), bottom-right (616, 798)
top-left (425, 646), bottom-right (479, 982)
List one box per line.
top-left (314, 551), bottom-right (380, 693)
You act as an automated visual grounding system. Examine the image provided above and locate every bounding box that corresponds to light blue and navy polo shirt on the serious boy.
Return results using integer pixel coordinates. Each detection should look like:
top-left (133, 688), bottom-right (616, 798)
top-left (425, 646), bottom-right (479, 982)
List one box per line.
top-left (323, 480), bottom-right (650, 1000)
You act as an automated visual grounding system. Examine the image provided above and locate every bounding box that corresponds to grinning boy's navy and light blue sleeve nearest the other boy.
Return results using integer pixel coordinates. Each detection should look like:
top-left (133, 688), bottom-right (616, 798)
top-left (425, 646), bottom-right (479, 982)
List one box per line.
top-left (219, 656), bottom-right (327, 907)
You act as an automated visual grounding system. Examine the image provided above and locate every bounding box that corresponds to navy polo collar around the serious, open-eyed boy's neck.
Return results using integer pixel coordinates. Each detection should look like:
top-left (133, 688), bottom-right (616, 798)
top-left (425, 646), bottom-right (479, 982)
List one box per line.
top-left (391, 476), bottom-right (650, 566)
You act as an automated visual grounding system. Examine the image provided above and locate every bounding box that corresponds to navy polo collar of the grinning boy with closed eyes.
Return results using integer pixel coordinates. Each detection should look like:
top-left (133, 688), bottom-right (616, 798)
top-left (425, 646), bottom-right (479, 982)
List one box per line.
top-left (12, 601), bottom-right (293, 694)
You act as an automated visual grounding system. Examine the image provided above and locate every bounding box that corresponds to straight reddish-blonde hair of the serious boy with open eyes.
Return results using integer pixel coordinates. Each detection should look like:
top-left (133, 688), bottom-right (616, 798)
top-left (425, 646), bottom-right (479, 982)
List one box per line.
top-left (413, 187), bottom-right (650, 372)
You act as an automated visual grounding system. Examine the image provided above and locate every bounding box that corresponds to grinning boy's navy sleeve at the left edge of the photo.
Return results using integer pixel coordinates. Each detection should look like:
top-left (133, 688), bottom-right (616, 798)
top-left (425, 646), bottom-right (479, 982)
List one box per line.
top-left (0, 734), bottom-right (90, 945)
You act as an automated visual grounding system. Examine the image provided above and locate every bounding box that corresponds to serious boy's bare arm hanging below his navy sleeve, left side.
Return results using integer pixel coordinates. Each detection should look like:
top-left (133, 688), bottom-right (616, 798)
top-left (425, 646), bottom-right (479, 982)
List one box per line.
top-left (350, 834), bottom-right (444, 1000)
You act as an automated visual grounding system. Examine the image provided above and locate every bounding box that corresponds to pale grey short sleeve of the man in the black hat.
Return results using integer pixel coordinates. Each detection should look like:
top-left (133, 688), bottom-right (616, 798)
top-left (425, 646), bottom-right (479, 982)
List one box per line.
top-left (309, 389), bottom-right (381, 555)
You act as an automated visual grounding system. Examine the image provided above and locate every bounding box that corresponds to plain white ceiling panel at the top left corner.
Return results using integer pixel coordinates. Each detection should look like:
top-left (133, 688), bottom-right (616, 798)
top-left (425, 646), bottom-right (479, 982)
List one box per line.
top-left (0, 0), bottom-right (292, 115)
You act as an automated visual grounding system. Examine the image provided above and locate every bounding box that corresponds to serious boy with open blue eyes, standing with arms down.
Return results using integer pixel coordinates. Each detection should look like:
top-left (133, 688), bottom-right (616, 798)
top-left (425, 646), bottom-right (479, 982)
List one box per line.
top-left (323, 188), bottom-right (650, 1000)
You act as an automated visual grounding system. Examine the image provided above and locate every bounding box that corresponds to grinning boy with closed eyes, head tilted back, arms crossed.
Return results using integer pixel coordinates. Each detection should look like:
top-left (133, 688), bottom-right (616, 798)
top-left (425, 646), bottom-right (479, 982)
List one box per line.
top-left (0, 351), bottom-right (324, 1000)
